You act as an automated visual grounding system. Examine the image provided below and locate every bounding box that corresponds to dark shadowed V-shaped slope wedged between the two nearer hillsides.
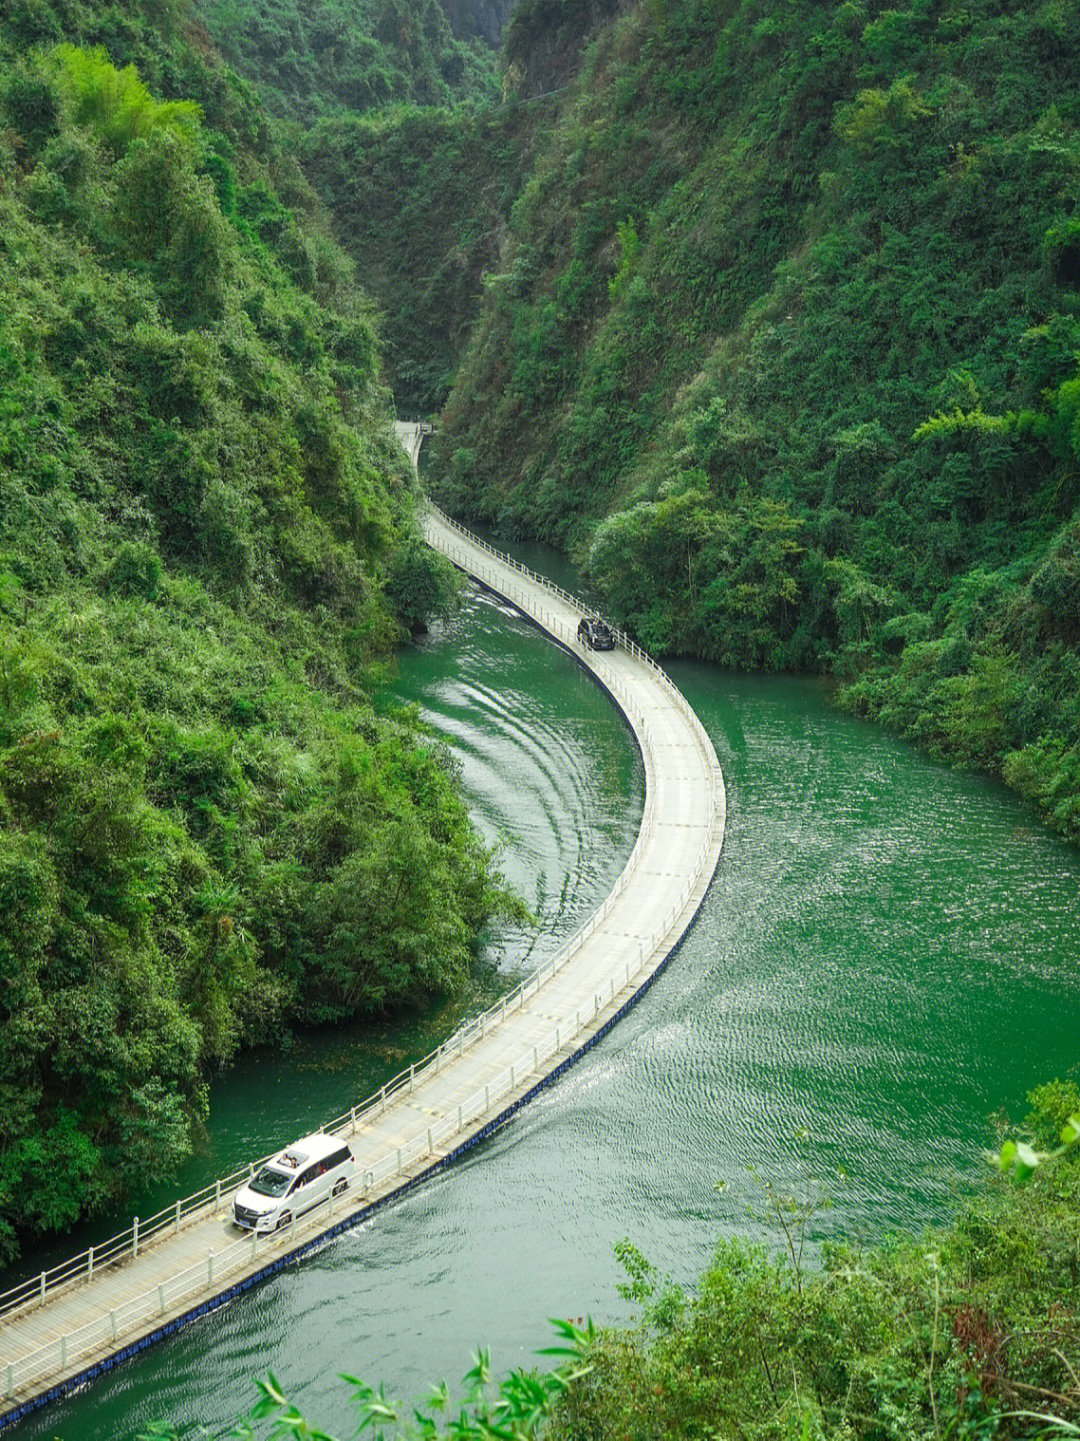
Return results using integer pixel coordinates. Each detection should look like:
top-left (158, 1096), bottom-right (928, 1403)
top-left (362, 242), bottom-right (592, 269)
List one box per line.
top-left (298, 0), bottom-right (614, 414)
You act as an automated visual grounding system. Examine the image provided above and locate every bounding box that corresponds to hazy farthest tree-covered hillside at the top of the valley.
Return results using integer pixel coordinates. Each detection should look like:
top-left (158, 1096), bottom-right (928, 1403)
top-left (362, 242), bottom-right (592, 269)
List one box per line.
top-left (196, 0), bottom-right (496, 124)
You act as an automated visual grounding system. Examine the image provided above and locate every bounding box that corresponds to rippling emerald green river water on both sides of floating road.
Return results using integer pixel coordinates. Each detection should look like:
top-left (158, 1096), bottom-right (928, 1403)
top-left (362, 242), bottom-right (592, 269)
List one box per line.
top-left (4, 541), bottom-right (1080, 1441)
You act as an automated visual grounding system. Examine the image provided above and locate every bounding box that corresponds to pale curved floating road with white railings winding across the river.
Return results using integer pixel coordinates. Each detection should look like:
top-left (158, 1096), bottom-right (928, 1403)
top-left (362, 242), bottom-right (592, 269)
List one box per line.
top-left (0, 440), bottom-right (724, 1428)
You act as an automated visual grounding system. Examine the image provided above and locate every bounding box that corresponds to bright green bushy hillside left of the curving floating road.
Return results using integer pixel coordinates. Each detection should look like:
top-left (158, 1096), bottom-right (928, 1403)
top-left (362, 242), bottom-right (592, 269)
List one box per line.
top-left (0, 0), bottom-right (519, 1255)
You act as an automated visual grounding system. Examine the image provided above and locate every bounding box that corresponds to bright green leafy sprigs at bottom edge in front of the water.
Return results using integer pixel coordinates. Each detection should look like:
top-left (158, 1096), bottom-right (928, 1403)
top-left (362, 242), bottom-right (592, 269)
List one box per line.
top-left (136, 1317), bottom-right (596, 1441)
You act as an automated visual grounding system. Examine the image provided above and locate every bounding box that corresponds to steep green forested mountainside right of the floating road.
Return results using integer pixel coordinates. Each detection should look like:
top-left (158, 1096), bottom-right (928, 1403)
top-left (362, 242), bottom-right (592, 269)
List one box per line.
top-left (434, 0), bottom-right (1080, 839)
